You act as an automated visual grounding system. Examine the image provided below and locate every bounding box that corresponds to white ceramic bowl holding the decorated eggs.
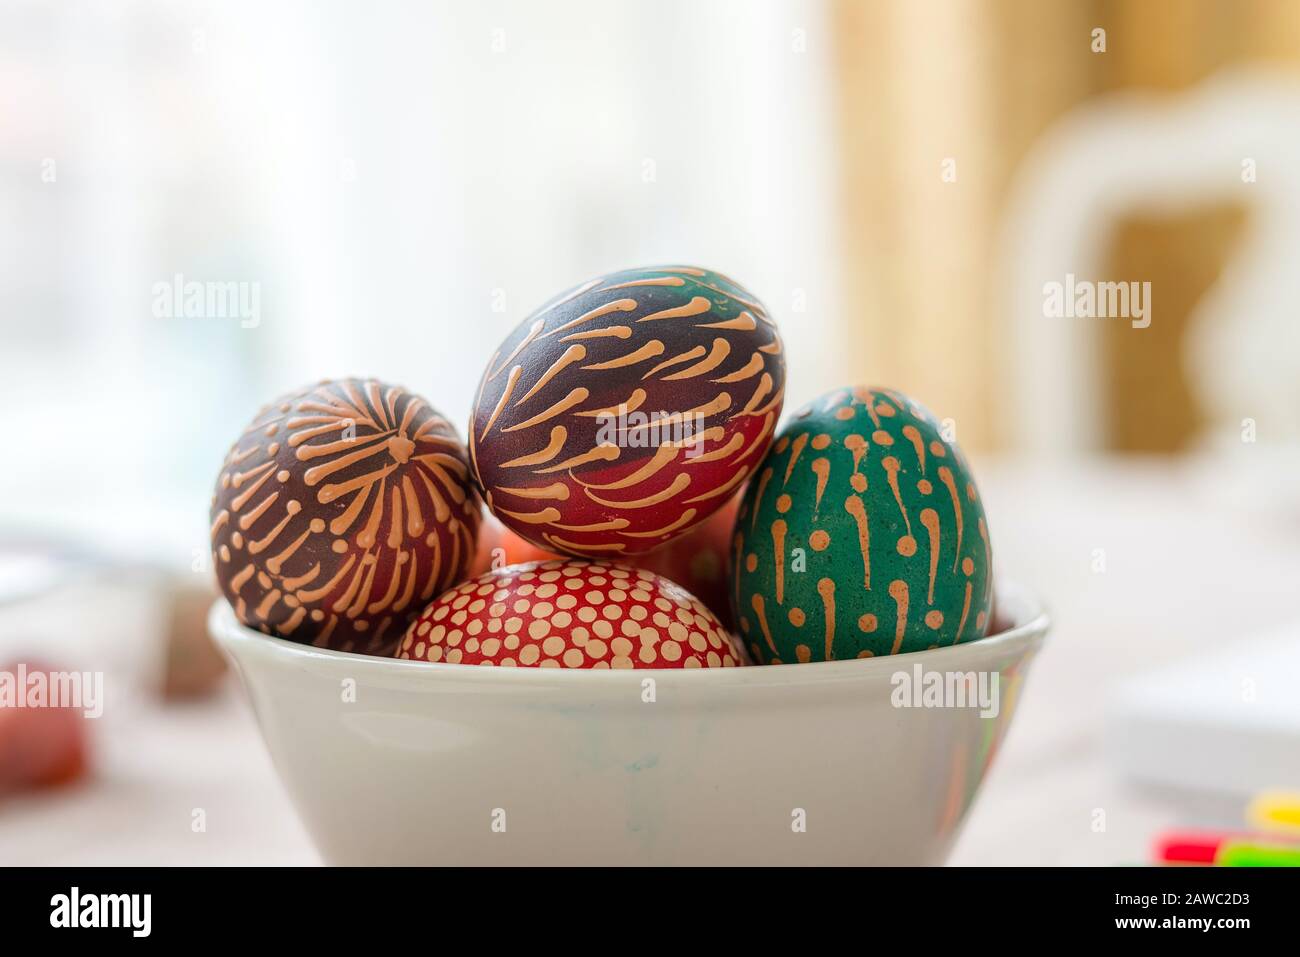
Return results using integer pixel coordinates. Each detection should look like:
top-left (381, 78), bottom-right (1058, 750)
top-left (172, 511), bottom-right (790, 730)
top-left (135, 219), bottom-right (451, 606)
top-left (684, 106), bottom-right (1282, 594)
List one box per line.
top-left (209, 579), bottom-right (1048, 865)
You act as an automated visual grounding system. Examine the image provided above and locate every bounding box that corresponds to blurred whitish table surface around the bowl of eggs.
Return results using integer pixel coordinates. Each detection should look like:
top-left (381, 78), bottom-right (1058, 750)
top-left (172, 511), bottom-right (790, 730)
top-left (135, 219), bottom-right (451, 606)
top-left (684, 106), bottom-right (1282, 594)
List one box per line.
top-left (0, 460), bottom-right (1300, 865)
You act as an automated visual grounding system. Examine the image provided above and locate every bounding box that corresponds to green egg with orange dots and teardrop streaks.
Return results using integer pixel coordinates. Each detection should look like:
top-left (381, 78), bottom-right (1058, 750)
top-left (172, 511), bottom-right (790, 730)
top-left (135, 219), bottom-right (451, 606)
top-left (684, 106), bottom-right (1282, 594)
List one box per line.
top-left (732, 389), bottom-right (992, 663)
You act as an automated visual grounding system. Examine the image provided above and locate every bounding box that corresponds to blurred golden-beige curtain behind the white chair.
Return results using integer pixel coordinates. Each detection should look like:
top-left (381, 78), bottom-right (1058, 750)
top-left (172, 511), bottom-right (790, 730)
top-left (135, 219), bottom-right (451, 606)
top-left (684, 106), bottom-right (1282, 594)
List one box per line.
top-left (833, 0), bottom-right (1300, 451)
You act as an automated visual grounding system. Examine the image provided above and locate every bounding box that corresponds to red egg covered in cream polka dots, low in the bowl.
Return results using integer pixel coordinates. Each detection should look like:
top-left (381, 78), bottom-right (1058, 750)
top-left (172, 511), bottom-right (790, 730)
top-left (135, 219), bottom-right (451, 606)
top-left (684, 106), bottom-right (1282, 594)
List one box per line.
top-left (397, 558), bottom-right (744, 668)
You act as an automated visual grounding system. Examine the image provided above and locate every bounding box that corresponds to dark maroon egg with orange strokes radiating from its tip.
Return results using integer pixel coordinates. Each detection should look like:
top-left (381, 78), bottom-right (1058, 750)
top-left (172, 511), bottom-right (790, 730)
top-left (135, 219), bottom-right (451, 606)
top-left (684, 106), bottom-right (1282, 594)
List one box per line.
top-left (212, 378), bottom-right (480, 655)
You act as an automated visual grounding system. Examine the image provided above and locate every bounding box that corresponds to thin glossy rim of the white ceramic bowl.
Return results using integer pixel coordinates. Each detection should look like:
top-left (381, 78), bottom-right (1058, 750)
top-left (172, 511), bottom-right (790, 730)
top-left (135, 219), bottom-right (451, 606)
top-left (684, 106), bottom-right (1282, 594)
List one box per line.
top-left (208, 581), bottom-right (1052, 688)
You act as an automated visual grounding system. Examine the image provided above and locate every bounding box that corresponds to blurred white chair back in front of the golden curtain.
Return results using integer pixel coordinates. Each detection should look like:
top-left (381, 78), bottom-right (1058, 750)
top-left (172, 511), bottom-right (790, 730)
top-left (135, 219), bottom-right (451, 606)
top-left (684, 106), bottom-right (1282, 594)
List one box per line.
top-left (1001, 73), bottom-right (1300, 455)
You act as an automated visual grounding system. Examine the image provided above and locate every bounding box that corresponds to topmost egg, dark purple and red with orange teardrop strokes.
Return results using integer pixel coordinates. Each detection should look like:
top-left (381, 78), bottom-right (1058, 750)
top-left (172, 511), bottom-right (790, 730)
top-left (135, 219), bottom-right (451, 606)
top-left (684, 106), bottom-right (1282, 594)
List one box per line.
top-left (469, 267), bottom-right (785, 558)
